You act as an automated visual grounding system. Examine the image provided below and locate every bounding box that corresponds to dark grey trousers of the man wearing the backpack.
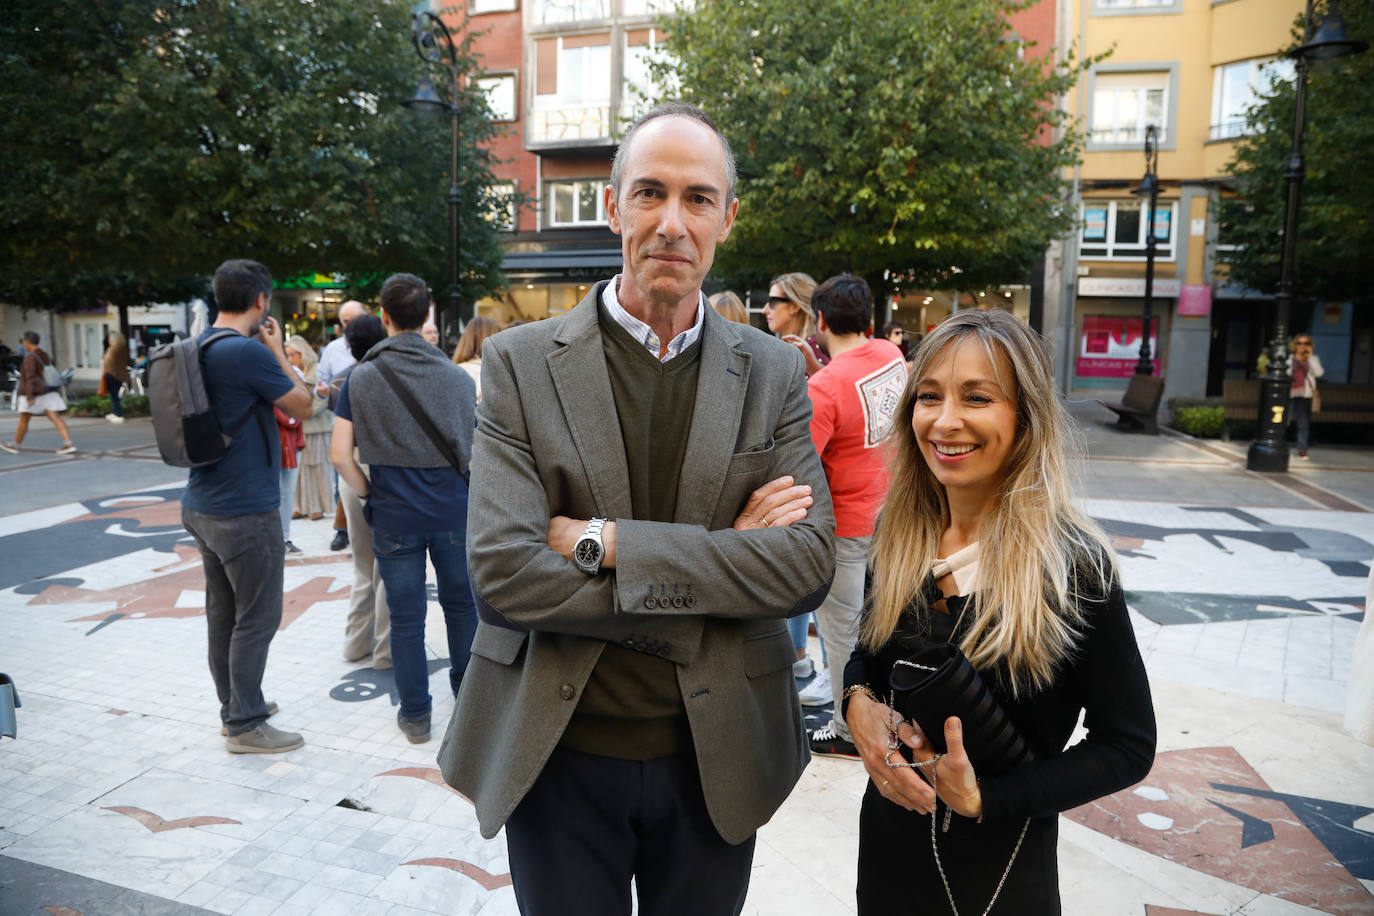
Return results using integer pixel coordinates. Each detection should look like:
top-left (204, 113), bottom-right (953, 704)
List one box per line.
top-left (181, 505), bottom-right (286, 735)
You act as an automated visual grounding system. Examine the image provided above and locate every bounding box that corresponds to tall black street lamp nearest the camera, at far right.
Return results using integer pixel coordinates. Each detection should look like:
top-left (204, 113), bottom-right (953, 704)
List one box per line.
top-left (1245, 0), bottom-right (1369, 471)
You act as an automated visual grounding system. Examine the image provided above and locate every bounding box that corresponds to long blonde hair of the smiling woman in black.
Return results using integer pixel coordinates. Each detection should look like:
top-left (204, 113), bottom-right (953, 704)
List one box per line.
top-left (861, 309), bottom-right (1116, 695)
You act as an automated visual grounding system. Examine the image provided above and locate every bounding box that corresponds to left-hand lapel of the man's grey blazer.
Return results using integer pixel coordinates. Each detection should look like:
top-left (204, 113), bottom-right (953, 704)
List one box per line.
top-left (548, 283), bottom-right (632, 518)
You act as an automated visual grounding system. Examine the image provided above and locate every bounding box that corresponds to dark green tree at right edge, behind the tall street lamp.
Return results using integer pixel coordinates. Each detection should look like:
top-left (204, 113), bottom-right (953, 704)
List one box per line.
top-left (1220, 3), bottom-right (1374, 302)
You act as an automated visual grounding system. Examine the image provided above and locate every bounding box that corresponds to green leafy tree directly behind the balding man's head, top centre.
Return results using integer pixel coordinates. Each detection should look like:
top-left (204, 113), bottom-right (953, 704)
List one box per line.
top-left (658, 0), bottom-right (1079, 293)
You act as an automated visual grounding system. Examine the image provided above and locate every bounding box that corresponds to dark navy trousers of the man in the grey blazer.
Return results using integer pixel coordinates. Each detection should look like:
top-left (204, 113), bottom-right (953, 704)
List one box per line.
top-left (506, 748), bottom-right (754, 916)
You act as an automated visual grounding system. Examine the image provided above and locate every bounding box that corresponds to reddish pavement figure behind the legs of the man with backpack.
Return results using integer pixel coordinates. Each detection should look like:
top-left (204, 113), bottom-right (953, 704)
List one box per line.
top-left (27, 556), bottom-right (349, 630)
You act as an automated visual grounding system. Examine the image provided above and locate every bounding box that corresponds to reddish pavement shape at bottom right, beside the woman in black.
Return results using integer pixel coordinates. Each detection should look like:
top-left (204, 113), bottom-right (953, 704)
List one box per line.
top-left (1065, 747), bottom-right (1371, 916)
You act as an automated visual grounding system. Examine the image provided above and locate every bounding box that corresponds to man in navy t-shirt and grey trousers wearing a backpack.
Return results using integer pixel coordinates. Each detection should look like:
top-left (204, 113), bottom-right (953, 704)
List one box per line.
top-left (181, 260), bottom-right (312, 754)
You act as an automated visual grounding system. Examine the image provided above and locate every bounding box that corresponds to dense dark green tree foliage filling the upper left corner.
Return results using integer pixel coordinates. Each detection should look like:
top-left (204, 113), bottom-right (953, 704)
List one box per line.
top-left (0, 0), bottom-right (511, 309)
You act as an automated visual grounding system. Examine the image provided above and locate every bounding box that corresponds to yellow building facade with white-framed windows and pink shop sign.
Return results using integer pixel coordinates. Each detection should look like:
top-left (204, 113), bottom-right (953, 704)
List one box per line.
top-left (1046, 0), bottom-right (1304, 397)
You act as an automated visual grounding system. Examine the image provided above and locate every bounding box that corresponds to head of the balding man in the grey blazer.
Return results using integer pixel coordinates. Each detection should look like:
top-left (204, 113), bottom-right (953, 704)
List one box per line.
top-left (605, 115), bottom-right (739, 309)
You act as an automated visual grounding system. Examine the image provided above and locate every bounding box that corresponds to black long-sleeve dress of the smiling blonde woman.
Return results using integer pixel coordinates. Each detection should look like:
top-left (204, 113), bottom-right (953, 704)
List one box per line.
top-left (845, 565), bottom-right (1156, 916)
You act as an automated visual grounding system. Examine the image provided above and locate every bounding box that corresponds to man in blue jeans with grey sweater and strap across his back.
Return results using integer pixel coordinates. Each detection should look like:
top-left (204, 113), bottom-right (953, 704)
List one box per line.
top-left (330, 273), bottom-right (477, 744)
